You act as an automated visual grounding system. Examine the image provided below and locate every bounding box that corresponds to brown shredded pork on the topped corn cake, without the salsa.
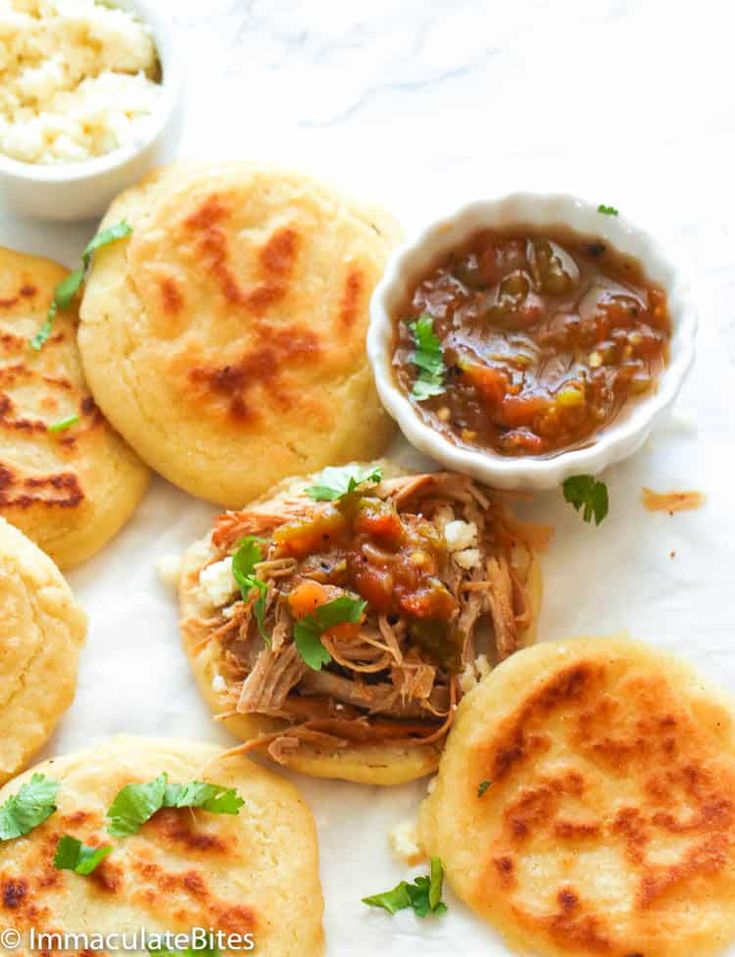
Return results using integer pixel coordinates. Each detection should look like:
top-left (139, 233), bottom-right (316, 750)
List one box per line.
top-left (193, 472), bottom-right (541, 763)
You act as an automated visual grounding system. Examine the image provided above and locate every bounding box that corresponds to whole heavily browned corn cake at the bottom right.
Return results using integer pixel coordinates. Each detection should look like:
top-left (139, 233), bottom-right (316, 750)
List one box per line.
top-left (420, 638), bottom-right (735, 957)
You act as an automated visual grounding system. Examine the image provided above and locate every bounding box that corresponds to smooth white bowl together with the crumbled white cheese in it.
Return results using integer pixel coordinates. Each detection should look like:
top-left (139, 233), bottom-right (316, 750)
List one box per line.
top-left (0, 0), bottom-right (182, 219)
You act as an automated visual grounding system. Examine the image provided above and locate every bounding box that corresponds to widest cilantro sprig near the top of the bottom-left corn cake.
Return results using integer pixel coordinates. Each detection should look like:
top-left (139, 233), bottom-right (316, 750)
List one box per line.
top-left (107, 772), bottom-right (245, 837)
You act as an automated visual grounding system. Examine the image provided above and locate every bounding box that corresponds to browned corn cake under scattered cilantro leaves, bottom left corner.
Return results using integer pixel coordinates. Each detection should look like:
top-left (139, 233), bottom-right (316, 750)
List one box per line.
top-left (0, 737), bottom-right (323, 957)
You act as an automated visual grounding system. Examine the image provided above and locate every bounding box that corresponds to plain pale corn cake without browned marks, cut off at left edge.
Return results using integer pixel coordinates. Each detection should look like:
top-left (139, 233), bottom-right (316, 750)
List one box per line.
top-left (0, 518), bottom-right (87, 782)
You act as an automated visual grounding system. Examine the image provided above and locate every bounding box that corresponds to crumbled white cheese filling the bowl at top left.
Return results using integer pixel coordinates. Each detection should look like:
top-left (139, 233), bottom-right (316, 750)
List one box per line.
top-left (0, 0), bottom-right (161, 163)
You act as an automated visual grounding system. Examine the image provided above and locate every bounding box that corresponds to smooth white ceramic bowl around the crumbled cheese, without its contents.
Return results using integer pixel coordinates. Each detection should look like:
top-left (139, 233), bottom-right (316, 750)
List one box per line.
top-left (0, 0), bottom-right (182, 220)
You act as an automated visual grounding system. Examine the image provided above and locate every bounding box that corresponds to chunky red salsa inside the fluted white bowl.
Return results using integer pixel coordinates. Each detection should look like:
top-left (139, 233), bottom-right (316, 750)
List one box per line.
top-left (393, 228), bottom-right (671, 455)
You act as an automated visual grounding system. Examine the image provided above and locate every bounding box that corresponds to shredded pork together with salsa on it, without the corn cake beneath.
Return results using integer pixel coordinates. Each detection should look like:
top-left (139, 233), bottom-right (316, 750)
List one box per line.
top-left (191, 472), bottom-right (533, 760)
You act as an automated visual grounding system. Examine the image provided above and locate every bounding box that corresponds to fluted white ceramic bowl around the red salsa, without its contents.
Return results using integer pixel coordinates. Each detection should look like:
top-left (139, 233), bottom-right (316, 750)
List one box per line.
top-left (367, 193), bottom-right (697, 490)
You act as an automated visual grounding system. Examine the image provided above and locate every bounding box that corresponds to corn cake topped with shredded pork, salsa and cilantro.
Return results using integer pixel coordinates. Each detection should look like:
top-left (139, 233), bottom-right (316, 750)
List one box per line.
top-left (180, 463), bottom-right (542, 784)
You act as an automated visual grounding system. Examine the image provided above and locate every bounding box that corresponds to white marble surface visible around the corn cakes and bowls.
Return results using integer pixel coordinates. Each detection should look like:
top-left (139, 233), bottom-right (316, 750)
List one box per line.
top-left (0, 0), bottom-right (735, 957)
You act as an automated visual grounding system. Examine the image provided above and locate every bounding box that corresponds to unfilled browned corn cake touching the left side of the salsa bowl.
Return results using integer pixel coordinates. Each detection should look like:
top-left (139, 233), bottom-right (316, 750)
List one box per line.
top-left (79, 163), bottom-right (397, 508)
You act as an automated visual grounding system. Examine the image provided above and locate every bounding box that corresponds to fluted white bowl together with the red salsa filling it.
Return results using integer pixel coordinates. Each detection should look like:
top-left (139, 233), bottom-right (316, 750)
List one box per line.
top-left (368, 193), bottom-right (696, 489)
